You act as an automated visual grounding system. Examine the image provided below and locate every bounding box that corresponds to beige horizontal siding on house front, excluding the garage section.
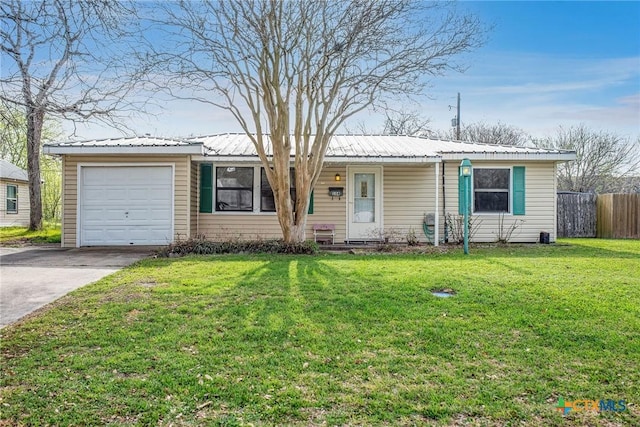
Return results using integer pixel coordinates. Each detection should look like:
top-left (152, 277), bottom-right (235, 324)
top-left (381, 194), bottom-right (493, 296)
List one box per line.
top-left (191, 162), bottom-right (556, 243)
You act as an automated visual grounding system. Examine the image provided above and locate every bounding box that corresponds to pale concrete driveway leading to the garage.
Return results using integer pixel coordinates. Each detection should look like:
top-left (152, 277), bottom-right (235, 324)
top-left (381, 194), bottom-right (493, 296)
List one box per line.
top-left (0, 246), bottom-right (153, 328)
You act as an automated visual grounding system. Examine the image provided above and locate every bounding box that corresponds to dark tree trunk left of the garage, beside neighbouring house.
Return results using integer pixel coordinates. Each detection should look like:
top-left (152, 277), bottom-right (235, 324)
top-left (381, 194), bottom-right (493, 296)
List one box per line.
top-left (27, 107), bottom-right (44, 230)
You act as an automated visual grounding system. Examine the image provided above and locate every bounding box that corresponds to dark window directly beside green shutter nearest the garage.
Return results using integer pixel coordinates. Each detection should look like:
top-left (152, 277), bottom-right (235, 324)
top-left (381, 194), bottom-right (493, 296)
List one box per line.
top-left (216, 167), bottom-right (253, 212)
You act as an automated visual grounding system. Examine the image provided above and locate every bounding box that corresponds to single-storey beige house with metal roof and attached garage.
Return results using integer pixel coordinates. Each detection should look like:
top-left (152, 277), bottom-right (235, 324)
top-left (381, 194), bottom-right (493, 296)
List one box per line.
top-left (44, 134), bottom-right (575, 247)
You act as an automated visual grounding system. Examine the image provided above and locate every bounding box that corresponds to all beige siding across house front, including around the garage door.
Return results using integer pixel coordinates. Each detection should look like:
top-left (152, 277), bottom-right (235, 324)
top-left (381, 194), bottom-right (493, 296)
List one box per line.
top-left (57, 156), bottom-right (556, 246)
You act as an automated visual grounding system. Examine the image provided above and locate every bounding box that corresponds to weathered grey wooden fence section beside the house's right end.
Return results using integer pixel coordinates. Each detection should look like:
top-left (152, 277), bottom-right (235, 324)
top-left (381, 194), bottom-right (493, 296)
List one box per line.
top-left (558, 192), bottom-right (597, 237)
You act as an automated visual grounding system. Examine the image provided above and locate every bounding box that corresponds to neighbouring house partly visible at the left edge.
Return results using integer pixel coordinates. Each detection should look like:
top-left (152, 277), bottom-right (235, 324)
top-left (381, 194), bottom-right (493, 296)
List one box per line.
top-left (0, 159), bottom-right (30, 227)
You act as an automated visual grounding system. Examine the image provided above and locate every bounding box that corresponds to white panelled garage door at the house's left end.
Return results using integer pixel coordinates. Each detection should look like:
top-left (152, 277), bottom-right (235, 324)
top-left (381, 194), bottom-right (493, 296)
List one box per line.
top-left (79, 166), bottom-right (173, 246)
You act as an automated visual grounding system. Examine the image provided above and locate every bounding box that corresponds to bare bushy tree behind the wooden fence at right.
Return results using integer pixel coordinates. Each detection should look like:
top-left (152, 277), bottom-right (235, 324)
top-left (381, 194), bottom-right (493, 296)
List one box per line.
top-left (538, 125), bottom-right (640, 193)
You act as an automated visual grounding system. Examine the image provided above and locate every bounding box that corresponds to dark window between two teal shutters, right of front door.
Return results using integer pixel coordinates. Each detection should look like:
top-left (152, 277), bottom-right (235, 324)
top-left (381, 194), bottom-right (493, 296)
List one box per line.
top-left (473, 169), bottom-right (511, 212)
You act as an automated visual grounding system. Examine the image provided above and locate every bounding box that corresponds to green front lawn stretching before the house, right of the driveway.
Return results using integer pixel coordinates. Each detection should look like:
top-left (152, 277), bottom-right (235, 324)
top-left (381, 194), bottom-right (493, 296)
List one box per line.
top-left (0, 240), bottom-right (640, 426)
